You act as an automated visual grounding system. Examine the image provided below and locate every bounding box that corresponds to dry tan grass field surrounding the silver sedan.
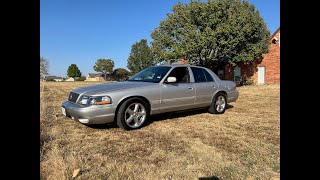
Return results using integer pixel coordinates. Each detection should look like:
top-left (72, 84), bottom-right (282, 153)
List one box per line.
top-left (40, 82), bottom-right (280, 180)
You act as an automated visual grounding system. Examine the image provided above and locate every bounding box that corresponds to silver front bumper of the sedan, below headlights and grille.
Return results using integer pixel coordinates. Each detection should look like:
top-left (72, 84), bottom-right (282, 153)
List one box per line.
top-left (62, 100), bottom-right (116, 124)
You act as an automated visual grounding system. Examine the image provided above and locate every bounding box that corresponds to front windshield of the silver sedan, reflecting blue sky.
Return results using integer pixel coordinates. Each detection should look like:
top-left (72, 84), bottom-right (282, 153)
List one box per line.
top-left (128, 66), bottom-right (171, 83)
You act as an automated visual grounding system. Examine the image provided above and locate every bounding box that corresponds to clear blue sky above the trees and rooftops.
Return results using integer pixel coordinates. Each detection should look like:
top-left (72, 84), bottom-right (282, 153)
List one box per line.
top-left (40, 0), bottom-right (280, 77)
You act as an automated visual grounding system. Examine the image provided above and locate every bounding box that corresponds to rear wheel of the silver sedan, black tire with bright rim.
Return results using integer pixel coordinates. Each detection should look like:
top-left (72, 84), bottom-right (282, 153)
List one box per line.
top-left (208, 92), bottom-right (227, 114)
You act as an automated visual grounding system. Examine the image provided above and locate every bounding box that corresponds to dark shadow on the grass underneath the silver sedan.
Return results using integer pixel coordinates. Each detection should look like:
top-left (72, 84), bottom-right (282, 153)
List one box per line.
top-left (84, 104), bottom-right (233, 129)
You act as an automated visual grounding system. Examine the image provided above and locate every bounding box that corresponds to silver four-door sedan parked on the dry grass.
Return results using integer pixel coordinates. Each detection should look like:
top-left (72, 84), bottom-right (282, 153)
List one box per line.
top-left (62, 65), bottom-right (239, 130)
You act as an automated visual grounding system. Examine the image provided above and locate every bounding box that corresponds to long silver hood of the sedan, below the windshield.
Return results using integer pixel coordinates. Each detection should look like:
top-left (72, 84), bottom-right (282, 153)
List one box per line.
top-left (72, 81), bottom-right (156, 95)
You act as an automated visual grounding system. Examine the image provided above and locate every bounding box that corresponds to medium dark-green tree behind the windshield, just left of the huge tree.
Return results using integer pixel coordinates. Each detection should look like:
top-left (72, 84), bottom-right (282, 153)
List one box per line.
top-left (127, 39), bottom-right (153, 74)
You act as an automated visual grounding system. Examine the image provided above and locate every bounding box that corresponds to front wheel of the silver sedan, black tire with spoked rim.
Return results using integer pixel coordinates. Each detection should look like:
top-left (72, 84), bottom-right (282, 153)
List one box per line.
top-left (117, 97), bottom-right (150, 130)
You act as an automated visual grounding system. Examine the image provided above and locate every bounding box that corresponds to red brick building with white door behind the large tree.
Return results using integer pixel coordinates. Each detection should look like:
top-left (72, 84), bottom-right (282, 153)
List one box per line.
top-left (214, 27), bottom-right (280, 84)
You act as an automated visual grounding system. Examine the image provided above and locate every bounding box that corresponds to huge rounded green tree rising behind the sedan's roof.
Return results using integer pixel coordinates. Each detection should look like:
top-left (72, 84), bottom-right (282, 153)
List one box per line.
top-left (151, 0), bottom-right (270, 66)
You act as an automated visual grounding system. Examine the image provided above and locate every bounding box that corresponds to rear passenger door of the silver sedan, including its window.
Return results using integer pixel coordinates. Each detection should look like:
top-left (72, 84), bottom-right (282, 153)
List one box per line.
top-left (191, 67), bottom-right (218, 107)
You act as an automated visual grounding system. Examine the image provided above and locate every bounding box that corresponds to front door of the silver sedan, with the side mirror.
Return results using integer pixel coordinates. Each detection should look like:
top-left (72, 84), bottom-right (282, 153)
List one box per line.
top-left (160, 67), bottom-right (195, 112)
